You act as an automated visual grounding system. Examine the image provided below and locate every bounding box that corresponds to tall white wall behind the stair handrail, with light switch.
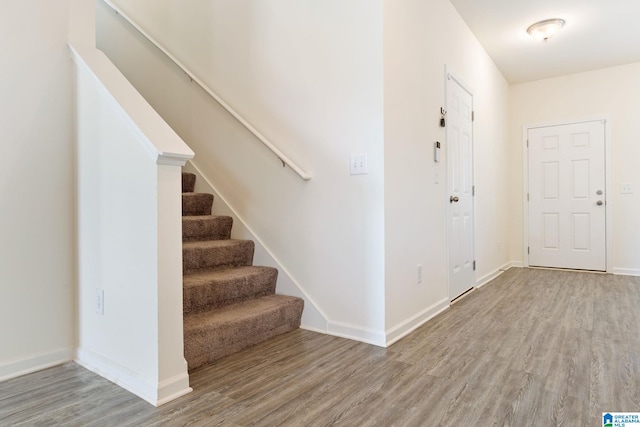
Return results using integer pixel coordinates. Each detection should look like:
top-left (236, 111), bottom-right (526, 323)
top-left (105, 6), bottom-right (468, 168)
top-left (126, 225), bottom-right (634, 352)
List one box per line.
top-left (98, 0), bottom-right (384, 344)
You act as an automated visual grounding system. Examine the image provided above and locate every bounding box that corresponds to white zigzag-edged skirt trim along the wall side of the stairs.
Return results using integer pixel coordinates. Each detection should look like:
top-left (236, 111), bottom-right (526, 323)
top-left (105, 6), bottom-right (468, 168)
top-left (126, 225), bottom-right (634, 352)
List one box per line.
top-left (183, 160), bottom-right (328, 334)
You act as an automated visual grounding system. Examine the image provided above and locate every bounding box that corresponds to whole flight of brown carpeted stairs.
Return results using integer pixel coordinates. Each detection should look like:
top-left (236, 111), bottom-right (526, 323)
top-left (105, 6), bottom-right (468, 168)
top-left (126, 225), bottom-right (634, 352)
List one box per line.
top-left (182, 173), bottom-right (304, 370)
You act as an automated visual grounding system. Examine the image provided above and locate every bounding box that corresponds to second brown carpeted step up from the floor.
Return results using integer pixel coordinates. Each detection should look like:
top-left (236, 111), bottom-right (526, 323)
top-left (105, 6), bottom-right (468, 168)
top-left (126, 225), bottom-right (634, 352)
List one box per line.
top-left (183, 265), bottom-right (278, 314)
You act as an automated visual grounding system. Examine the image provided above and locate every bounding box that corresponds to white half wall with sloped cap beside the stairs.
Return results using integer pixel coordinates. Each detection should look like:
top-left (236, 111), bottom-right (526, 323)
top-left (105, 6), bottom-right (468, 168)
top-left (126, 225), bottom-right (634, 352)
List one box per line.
top-left (72, 47), bottom-right (193, 405)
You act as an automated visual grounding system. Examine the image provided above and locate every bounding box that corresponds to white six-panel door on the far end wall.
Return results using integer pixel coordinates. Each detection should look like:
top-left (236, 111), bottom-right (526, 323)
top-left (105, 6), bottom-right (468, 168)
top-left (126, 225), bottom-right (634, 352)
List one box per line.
top-left (527, 120), bottom-right (607, 271)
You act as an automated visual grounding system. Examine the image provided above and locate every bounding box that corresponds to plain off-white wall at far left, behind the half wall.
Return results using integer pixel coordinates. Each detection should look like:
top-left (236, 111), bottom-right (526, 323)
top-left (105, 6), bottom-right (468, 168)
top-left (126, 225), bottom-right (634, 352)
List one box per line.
top-left (0, 0), bottom-right (75, 379)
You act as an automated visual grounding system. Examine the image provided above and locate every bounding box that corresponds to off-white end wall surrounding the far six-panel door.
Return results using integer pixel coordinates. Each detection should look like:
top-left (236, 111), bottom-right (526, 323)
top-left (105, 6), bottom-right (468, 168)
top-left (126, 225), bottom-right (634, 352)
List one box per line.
top-left (509, 63), bottom-right (640, 275)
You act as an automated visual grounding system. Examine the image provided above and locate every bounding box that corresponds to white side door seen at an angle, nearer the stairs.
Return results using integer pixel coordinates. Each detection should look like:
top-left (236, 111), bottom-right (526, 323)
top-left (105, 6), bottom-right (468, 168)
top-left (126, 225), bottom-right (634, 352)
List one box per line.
top-left (446, 75), bottom-right (475, 300)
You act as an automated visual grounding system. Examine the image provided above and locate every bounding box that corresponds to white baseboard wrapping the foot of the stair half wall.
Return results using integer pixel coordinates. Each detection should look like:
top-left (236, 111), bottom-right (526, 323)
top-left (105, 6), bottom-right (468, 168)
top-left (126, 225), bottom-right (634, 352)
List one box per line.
top-left (76, 348), bottom-right (192, 406)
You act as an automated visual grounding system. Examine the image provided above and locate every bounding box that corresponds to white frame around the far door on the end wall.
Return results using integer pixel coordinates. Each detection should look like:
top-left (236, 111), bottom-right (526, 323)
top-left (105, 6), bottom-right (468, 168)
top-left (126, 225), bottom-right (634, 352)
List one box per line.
top-left (522, 116), bottom-right (613, 273)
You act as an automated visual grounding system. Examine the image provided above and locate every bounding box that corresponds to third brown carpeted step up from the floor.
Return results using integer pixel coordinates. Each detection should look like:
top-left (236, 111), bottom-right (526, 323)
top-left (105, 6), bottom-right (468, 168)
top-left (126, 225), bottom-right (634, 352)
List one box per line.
top-left (182, 239), bottom-right (255, 275)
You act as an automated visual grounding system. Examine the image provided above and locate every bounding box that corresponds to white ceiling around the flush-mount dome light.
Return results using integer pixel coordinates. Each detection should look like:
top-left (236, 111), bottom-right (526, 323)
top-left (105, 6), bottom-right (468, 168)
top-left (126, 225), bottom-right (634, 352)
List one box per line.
top-left (451, 0), bottom-right (640, 83)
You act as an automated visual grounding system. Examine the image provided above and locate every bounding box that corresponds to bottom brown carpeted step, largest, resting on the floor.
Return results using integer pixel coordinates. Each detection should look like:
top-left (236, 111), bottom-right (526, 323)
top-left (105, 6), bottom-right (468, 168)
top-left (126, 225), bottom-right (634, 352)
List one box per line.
top-left (184, 295), bottom-right (304, 370)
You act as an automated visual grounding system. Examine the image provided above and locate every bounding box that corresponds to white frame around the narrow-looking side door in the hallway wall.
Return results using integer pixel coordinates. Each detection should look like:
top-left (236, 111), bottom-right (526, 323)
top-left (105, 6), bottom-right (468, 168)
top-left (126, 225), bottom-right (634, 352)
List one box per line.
top-left (444, 65), bottom-right (477, 301)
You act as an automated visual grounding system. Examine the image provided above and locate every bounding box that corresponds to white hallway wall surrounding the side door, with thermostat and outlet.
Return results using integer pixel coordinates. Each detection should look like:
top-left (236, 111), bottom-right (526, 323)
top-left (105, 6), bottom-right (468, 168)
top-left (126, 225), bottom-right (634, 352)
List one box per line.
top-left (384, 0), bottom-right (510, 340)
